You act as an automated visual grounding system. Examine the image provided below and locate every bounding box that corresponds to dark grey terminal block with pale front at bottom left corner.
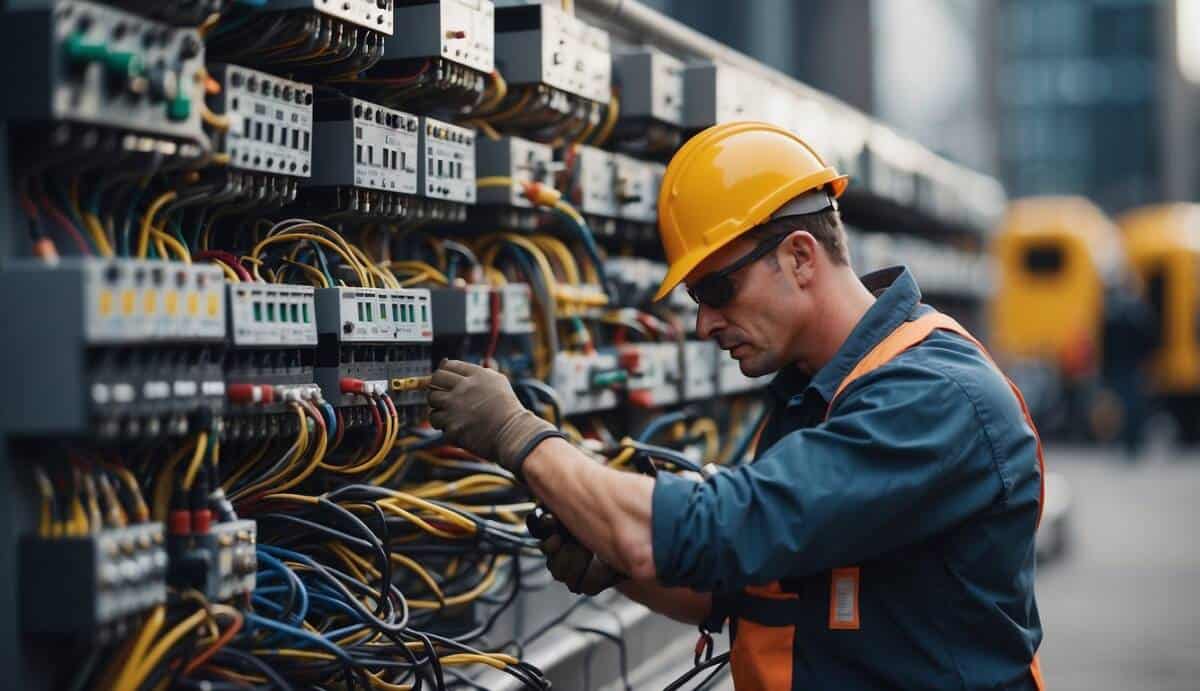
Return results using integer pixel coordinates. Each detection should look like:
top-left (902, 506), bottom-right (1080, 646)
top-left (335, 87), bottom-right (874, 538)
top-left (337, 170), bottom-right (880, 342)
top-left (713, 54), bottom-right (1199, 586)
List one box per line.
top-left (18, 523), bottom-right (167, 643)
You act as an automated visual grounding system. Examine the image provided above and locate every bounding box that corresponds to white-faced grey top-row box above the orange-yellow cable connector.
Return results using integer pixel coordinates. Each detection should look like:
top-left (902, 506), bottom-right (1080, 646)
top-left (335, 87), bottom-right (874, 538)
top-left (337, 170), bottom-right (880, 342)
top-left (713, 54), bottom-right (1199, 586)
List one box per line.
top-left (496, 2), bottom-right (612, 103)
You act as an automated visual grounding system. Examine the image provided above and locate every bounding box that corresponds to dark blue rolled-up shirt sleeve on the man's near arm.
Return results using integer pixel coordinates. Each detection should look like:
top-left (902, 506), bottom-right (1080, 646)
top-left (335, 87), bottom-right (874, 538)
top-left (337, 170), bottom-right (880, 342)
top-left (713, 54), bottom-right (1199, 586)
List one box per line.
top-left (652, 360), bottom-right (1004, 591)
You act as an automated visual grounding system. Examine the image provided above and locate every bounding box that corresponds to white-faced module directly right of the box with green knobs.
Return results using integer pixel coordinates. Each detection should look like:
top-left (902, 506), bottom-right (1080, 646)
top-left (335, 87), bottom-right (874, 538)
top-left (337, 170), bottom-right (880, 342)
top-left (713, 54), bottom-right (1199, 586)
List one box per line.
top-left (209, 65), bottom-right (313, 178)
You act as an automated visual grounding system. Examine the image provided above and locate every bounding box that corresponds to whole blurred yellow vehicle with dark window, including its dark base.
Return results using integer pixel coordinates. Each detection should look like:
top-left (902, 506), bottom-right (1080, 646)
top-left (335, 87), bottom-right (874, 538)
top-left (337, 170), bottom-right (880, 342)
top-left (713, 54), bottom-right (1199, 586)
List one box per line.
top-left (990, 197), bottom-right (1123, 439)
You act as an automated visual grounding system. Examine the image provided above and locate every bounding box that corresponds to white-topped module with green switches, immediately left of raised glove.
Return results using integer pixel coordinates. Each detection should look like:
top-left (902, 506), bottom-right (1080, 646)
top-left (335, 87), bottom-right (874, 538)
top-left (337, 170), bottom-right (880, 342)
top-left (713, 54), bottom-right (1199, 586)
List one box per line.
top-left (316, 288), bottom-right (433, 414)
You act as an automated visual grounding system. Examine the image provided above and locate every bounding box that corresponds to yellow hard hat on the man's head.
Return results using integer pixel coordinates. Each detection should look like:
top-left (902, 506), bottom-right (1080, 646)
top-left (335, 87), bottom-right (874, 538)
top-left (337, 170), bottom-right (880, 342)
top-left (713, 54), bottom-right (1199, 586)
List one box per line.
top-left (654, 121), bottom-right (850, 300)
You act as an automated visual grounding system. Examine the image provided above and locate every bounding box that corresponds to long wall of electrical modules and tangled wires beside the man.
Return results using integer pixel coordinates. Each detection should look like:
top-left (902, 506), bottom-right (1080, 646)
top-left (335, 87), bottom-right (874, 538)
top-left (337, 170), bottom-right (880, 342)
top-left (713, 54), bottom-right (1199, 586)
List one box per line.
top-left (0, 0), bottom-right (1003, 691)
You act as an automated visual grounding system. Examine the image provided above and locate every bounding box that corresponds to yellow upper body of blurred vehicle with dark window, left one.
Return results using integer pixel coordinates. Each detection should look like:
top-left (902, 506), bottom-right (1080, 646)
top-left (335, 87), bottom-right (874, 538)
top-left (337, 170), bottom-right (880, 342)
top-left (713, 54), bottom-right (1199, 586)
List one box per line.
top-left (991, 197), bottom-right (1122, 379)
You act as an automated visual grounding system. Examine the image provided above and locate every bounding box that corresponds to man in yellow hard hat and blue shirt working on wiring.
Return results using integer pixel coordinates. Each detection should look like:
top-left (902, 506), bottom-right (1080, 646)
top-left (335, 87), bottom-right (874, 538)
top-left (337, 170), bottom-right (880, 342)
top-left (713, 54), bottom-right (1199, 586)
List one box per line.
top-left (430, 122), bottom-right (1043, 691)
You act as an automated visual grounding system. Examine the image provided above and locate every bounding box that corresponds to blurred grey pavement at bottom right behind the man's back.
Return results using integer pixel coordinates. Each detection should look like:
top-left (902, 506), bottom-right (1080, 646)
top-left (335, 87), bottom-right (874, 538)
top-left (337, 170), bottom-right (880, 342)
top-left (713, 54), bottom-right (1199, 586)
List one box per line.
top-left (1037, 447), bottom-right (1200, 691)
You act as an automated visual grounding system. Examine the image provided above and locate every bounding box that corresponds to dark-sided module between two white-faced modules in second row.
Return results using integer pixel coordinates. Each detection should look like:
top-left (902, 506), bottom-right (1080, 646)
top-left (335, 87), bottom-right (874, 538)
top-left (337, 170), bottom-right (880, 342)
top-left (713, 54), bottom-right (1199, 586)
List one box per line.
top-left (308, 98), bottom-right (419, 194)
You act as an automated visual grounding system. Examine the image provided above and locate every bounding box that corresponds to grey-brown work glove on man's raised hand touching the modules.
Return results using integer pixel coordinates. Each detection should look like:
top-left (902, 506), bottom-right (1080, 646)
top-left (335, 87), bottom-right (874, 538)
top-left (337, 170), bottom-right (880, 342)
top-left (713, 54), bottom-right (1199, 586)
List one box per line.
top-left (430, 360), bottom-right (566, 481)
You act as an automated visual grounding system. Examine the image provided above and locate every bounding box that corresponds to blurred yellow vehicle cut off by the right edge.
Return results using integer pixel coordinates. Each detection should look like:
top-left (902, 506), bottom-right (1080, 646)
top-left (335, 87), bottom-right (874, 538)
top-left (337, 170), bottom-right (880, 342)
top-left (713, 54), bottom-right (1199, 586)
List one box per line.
top-left (1118, 204), bottom-right (1200, 443)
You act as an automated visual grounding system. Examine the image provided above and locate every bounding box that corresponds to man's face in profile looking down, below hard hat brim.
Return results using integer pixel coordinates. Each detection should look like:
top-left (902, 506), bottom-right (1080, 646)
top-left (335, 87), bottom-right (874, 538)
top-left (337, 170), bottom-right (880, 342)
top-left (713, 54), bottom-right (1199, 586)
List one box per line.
top-left (686, 236), bottom-right (814, 377)
